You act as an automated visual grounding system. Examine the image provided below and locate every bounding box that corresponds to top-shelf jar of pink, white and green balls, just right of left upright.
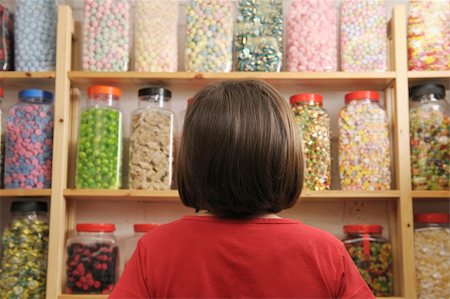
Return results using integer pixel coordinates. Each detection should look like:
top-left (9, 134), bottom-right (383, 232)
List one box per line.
top-left (81, 0), bottom-right (130, 72)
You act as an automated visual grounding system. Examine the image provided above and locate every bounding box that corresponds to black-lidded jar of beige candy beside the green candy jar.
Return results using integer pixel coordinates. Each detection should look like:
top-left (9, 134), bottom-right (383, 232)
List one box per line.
top-left (128, 87), bottom-right (174, 190)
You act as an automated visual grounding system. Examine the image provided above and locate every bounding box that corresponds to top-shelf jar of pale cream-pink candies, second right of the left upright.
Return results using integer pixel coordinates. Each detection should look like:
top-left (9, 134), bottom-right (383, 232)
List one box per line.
top-left (134, 0), bottom-right (178, 72)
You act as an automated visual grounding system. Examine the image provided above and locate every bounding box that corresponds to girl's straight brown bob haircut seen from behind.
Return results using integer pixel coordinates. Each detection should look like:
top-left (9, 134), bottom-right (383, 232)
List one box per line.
top-left (177, 80), bottom-right (304, 218)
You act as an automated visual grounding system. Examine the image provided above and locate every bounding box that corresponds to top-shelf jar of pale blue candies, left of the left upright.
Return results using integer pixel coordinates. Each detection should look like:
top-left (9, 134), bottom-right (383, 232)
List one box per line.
top-left (14, 0), bottom-right (57, 72)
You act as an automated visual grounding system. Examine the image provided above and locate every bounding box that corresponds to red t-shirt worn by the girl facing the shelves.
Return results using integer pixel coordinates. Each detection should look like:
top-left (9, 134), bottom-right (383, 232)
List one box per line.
top-left (109, 216), bottom-right (375, 299)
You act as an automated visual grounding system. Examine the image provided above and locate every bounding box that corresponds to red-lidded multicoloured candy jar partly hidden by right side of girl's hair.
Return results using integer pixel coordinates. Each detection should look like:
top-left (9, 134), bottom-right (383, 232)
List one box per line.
top-left (290, 93), bottom-right (331, 191)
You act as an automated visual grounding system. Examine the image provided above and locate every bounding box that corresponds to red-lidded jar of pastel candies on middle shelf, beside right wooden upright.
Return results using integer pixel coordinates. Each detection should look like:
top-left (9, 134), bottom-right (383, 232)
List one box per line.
top-left (338, 90), bottom-right (391, 191)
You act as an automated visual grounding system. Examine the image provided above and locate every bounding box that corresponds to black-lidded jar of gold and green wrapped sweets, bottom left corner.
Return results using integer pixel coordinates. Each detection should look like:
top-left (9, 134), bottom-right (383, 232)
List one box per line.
top-left (0, 201), bottom-right (49, 298)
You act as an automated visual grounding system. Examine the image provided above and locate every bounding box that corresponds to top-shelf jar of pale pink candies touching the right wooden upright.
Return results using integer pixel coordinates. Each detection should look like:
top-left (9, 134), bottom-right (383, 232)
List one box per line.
top-left (340, 0), bottom-right (387, 72)
